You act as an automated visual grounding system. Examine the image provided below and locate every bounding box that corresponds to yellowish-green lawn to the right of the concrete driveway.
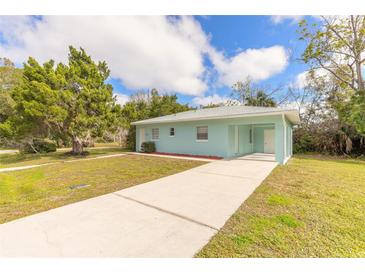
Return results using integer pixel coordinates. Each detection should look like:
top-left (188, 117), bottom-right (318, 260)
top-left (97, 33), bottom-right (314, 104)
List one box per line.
top-left (196, 155), bottom-right (365, 257)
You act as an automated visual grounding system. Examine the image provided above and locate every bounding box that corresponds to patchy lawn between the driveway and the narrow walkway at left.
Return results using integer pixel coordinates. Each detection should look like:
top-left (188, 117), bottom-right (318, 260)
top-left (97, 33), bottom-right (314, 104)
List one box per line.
top-left (0, 155), bottom-right (204, 223)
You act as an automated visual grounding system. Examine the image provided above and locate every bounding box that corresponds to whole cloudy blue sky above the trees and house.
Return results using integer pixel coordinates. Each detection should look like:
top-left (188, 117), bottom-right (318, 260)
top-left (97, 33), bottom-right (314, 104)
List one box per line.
top-left (0, 16), bottom-right (316, 105)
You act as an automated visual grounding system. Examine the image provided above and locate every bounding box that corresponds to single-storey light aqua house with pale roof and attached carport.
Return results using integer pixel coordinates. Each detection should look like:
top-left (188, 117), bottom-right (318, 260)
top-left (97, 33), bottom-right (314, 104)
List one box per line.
top-left (132, 106), bottom-right (299, 164)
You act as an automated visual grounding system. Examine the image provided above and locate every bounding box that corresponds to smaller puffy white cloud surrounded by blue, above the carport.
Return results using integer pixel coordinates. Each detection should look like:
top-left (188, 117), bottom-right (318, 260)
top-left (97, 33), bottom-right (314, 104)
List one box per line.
top-left (211, 46), bottom-right (288, 86)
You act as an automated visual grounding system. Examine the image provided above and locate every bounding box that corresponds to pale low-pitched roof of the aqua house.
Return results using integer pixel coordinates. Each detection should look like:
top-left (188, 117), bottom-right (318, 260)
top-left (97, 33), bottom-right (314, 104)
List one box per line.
top-left (132, 106), bottom-right (300, 125)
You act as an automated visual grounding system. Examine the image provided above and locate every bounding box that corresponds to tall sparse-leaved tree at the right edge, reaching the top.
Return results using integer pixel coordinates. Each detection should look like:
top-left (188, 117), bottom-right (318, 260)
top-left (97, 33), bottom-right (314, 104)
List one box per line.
top-left (300, 16), bottom-right (365, 136)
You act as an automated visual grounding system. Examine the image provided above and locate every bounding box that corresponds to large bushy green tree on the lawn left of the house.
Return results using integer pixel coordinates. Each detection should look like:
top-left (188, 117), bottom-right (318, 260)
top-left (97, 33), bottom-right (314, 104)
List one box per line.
top-left (13, 46), bottom-right (120, 154)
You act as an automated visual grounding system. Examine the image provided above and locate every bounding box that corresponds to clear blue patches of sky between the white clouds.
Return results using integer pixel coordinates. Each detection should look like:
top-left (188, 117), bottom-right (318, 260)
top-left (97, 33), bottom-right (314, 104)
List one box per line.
top-left (106, 16), bottom-right (314, 103)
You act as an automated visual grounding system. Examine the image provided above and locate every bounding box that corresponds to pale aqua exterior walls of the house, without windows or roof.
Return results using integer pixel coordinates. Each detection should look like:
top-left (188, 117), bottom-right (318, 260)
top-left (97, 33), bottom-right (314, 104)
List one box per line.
top-left (136, 115), bottom-right (290, 163)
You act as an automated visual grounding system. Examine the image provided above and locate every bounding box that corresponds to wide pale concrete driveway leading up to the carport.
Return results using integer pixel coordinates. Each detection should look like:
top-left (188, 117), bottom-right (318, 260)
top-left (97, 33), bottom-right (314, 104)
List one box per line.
top-left (0, 154), bottom-right (277, 257)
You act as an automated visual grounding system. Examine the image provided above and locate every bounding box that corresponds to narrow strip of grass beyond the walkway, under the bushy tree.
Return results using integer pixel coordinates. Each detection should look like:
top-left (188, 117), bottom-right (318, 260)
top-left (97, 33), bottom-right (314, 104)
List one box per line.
top-left (0, 147), bottom-right (127, 168)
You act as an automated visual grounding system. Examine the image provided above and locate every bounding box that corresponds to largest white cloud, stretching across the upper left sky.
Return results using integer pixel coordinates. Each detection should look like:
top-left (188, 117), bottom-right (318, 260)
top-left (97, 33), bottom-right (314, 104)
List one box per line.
top-left (0, 16), bottom-right (207, 95)
